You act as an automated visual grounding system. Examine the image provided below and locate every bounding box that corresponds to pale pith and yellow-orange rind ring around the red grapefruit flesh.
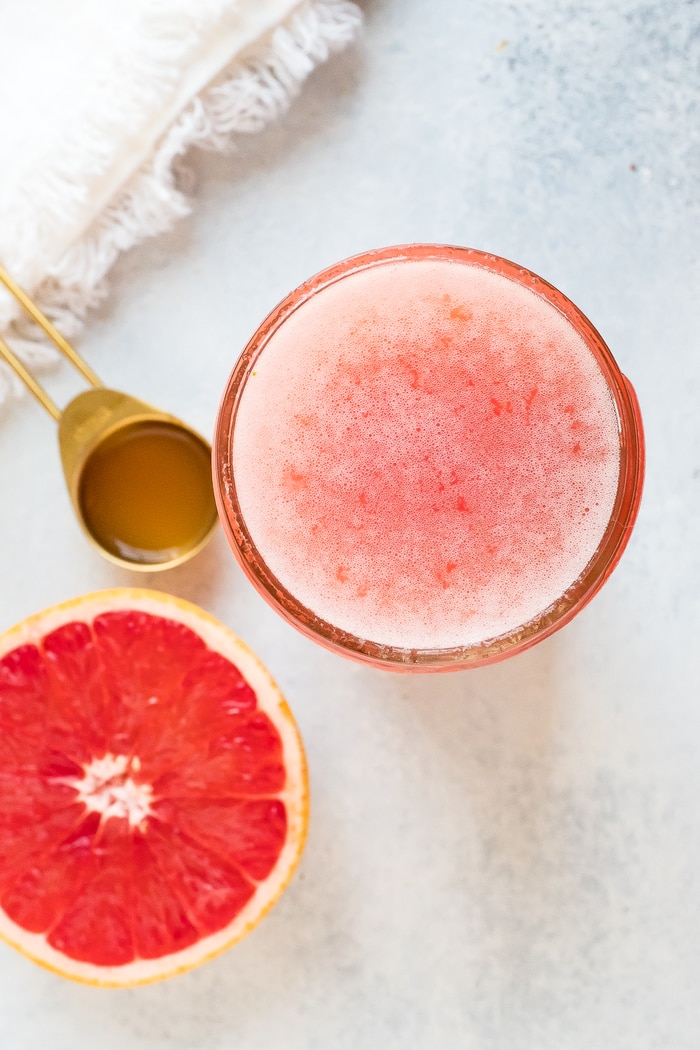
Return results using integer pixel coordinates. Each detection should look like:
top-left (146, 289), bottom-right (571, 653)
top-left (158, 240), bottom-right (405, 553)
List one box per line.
top-left (0, 588), bottom-right (309, 988)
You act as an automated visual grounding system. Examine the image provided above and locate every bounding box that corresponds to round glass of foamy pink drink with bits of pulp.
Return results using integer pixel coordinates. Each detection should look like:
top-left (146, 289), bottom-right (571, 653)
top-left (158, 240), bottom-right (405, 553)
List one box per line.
top-left (215, 247), bottom-right (640, 666)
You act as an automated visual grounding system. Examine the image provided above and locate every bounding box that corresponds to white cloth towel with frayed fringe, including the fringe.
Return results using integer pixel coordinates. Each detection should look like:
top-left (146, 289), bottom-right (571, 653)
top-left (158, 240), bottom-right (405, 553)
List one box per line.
top-left (0, 0), bottom-right (361, 402)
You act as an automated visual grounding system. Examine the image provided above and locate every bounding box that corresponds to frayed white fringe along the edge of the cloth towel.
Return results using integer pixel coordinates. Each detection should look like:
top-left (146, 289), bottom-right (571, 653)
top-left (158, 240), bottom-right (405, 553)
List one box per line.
top-left (0, 0), bottom-right (362, 403)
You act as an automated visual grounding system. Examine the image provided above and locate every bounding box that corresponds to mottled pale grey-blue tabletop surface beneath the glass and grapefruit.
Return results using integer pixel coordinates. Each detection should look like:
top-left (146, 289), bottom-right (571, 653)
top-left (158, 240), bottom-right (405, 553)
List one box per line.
top-left (0, 0), bottom-right (700, 1050)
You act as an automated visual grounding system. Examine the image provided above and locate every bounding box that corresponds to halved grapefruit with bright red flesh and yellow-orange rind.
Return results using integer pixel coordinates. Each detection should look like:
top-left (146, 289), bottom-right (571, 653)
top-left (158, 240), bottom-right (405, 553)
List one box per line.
top-left (0, 589), bottom-right (309, 986)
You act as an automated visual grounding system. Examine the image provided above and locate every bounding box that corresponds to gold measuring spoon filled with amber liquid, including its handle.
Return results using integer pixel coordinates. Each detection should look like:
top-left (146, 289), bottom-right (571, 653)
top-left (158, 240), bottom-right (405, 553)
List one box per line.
top-left (0, 267), bottom-right (218, 570)
